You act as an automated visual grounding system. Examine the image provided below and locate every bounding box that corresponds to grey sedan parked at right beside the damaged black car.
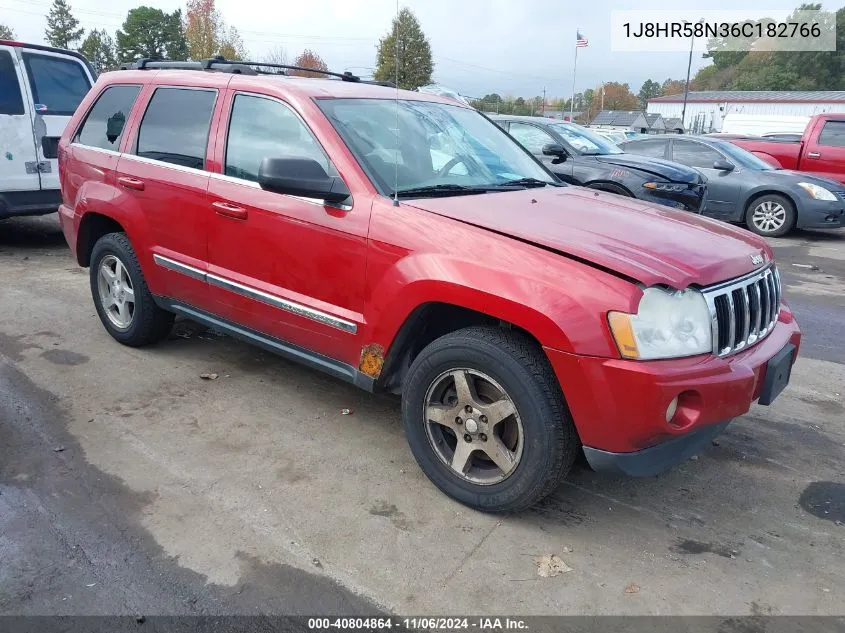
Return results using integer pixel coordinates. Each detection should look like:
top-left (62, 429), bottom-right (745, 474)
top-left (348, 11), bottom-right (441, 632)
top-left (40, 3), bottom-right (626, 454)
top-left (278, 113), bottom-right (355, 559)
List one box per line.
top-left (622, 136), bottom-right (845, 237)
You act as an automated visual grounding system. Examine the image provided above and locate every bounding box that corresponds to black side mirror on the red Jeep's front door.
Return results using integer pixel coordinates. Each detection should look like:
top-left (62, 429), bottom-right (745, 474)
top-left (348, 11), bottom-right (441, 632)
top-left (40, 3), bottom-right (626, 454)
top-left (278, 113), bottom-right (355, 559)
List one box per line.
top-left (258, 158), bottom-right (351, 202)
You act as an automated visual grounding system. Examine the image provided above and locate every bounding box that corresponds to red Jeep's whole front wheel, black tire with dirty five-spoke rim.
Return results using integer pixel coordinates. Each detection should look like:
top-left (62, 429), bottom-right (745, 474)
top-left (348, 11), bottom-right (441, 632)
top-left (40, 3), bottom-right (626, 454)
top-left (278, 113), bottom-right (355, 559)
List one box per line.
top-left (402, 327), bottom-right (580, 513)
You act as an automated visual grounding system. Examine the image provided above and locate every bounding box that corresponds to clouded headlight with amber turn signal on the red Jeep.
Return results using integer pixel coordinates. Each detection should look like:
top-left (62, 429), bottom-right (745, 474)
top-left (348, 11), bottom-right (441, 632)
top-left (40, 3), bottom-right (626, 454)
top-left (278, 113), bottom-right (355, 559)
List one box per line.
top-left (607, 288), bottom-right (713, 360)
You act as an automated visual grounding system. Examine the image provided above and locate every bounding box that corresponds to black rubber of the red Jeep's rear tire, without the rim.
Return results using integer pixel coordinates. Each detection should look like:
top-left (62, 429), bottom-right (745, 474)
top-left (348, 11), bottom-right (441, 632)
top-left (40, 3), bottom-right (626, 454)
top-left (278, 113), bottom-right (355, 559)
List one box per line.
top-left (89, 234), bottom-right (156, 345)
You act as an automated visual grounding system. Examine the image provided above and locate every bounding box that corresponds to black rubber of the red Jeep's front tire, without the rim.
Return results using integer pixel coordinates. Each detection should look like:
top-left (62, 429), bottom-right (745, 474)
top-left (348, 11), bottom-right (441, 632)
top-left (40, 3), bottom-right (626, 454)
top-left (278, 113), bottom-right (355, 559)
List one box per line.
top-left (402, 334), bottom-right (563, 512)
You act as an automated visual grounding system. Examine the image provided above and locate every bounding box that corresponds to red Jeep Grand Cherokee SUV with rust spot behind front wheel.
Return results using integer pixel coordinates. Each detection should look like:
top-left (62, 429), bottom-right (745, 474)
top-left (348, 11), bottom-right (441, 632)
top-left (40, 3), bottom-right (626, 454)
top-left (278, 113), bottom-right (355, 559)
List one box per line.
top-left (60, 60), bottom-right (800, 512)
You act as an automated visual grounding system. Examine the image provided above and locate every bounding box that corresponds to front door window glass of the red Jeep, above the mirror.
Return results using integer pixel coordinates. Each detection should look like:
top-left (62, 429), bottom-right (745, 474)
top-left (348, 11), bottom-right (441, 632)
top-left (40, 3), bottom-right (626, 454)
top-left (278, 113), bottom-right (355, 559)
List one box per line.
top-left (225, 94), bottom-right (337, 181)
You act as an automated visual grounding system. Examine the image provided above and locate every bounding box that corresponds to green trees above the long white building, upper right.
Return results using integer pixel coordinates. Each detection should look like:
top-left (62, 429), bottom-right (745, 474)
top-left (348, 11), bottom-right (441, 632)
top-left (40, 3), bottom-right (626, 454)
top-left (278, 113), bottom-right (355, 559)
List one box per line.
top-left (693, 4), bottom-right (845, 90)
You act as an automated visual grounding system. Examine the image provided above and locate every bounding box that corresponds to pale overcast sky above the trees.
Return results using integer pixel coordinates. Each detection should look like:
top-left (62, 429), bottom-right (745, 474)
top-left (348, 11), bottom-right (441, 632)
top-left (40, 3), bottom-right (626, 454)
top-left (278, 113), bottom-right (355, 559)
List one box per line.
top-left (0, 0), bottom-right (842, 97)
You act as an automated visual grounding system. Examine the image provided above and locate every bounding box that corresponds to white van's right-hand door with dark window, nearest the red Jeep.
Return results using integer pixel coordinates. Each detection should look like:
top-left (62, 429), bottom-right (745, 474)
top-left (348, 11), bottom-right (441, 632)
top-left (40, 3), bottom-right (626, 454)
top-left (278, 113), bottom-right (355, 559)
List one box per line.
top-left (19, 48), bottom-right (94, 189)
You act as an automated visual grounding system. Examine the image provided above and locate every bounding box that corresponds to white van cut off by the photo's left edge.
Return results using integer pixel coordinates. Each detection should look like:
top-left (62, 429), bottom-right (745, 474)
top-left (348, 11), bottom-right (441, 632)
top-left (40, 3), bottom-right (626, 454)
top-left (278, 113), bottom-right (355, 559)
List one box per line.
top-left (0, 40), bottom-right (95, 218)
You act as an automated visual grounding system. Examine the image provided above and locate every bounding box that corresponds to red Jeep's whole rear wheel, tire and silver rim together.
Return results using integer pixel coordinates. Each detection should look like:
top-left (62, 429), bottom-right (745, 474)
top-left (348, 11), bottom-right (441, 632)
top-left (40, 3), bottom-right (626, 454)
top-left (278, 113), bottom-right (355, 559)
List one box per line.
top-left (89, 233), bottom-right (175, 347)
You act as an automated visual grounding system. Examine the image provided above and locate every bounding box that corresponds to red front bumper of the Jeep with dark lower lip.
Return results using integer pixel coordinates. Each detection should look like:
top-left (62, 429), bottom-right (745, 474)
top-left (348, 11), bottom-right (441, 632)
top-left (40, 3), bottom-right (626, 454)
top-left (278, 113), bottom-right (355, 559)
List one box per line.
top-left (546, 306), bottom-right (801, 475)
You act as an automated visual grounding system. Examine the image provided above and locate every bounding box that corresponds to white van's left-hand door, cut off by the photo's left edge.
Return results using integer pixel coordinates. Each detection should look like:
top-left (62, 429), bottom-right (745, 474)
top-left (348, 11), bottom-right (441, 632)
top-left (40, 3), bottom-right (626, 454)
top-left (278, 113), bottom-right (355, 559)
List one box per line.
top-left (0, 45), bottom-right (41, 193)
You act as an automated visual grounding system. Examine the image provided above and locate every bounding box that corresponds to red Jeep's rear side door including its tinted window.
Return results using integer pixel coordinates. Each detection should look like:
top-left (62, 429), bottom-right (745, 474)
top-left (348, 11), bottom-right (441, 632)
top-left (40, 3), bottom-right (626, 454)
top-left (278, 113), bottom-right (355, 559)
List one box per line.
top-left (115, 87), bottom-right (218, 309)
